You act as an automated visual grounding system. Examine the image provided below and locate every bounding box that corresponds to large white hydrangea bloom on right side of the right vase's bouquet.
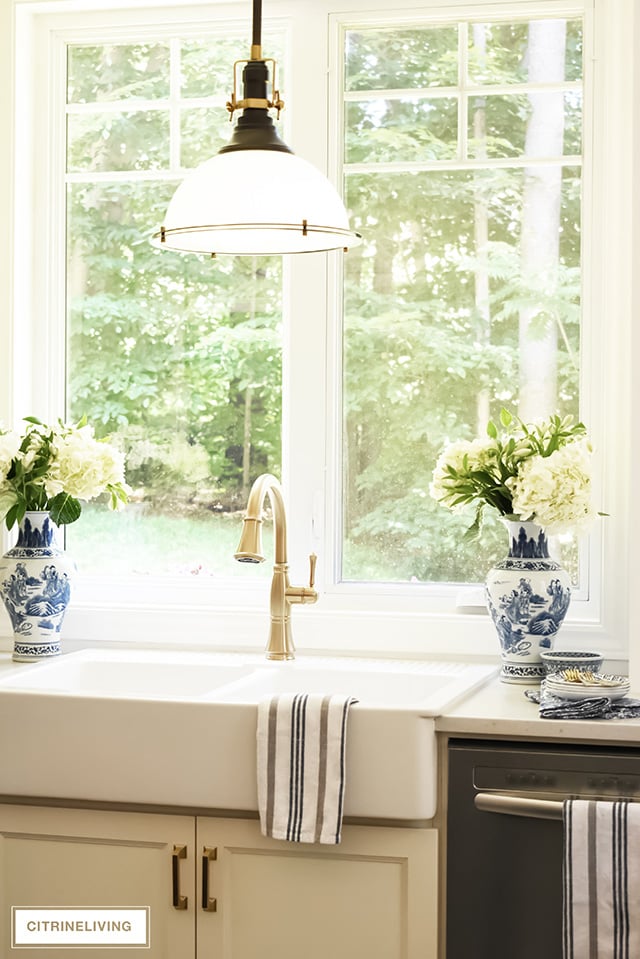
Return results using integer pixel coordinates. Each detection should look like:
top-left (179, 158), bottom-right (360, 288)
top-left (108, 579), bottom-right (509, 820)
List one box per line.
top-left (507, 440), bottom-right (595, 534)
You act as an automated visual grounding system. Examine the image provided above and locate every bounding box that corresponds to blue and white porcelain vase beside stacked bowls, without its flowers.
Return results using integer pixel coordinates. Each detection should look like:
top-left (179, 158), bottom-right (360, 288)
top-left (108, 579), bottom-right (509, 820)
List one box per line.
top-left (486, 520), bottom-right (571, 684)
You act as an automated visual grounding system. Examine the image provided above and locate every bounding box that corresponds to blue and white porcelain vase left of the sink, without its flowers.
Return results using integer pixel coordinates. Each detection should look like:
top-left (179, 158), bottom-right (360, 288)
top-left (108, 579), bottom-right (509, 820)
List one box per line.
top-left (0, 512), bottom-right (75, 663)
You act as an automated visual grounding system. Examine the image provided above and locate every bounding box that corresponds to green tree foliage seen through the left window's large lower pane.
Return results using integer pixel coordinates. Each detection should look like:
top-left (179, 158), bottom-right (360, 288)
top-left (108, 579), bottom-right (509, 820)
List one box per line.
top-left (69, 174), bottom-right (281, 508)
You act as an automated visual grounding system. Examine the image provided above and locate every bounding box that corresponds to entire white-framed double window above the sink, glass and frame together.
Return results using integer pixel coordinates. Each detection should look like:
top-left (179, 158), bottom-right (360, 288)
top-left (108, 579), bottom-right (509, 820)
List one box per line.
top-left (8, 0), bottom-right (631, 652)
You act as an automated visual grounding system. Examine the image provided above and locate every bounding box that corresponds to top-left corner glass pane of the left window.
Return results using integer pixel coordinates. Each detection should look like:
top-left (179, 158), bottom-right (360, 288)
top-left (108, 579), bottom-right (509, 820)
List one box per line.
top-left (67, 43), bottom-right (169, 103)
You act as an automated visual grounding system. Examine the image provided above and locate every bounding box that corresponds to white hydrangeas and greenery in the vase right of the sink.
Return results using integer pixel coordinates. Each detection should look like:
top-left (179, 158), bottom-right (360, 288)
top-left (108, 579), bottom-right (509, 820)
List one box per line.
top-left (429, 409), bottom-right (596, 538)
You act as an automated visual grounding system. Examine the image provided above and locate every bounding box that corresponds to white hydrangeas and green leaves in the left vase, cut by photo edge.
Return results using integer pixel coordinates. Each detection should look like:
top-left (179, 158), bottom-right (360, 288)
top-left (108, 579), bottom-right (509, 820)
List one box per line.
top-left (0, 416), bottom-right (129, 529)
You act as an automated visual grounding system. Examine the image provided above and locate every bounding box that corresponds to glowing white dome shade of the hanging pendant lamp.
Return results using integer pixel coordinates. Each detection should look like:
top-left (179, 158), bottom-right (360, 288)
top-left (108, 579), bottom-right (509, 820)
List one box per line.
top-left (153, 149), bottom-right (361, 255)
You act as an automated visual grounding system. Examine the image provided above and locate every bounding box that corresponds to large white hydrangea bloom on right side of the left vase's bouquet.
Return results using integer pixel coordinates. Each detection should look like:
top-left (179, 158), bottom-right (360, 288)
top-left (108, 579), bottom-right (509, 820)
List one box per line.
top-left (45, 426), bottom-right (124, 500)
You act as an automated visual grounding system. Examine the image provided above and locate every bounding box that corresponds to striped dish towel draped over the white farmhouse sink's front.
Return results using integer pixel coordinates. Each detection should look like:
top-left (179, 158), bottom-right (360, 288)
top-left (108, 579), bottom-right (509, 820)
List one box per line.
top-left (257, 693), bottom-right (357, 843)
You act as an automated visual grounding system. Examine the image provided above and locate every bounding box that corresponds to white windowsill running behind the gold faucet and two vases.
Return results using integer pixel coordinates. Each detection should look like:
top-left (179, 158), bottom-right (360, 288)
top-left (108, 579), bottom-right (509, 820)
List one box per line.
top-left (0, 596), bottom-right (628, 659)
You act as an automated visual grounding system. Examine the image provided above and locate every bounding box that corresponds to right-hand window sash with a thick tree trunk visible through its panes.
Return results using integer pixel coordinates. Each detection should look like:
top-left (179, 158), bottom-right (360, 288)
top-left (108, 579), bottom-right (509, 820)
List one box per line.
top-left (342, 17), bottom-right (583, 585)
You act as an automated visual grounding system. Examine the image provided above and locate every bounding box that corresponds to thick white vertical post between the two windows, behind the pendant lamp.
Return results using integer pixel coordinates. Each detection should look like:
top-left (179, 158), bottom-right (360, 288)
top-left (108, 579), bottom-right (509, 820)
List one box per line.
top-left (282, 4), bottom-right (332, 592)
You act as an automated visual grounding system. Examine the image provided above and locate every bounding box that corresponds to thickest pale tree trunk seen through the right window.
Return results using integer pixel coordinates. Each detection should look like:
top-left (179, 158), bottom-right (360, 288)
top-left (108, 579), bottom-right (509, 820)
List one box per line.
top-left (519, 20), bottom-right (566, 421)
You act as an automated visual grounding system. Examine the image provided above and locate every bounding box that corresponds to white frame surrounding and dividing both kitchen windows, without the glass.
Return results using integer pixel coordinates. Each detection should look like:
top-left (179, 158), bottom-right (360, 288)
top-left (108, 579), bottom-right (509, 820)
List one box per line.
top-left (0, 0), bottom-right (640, 659)
